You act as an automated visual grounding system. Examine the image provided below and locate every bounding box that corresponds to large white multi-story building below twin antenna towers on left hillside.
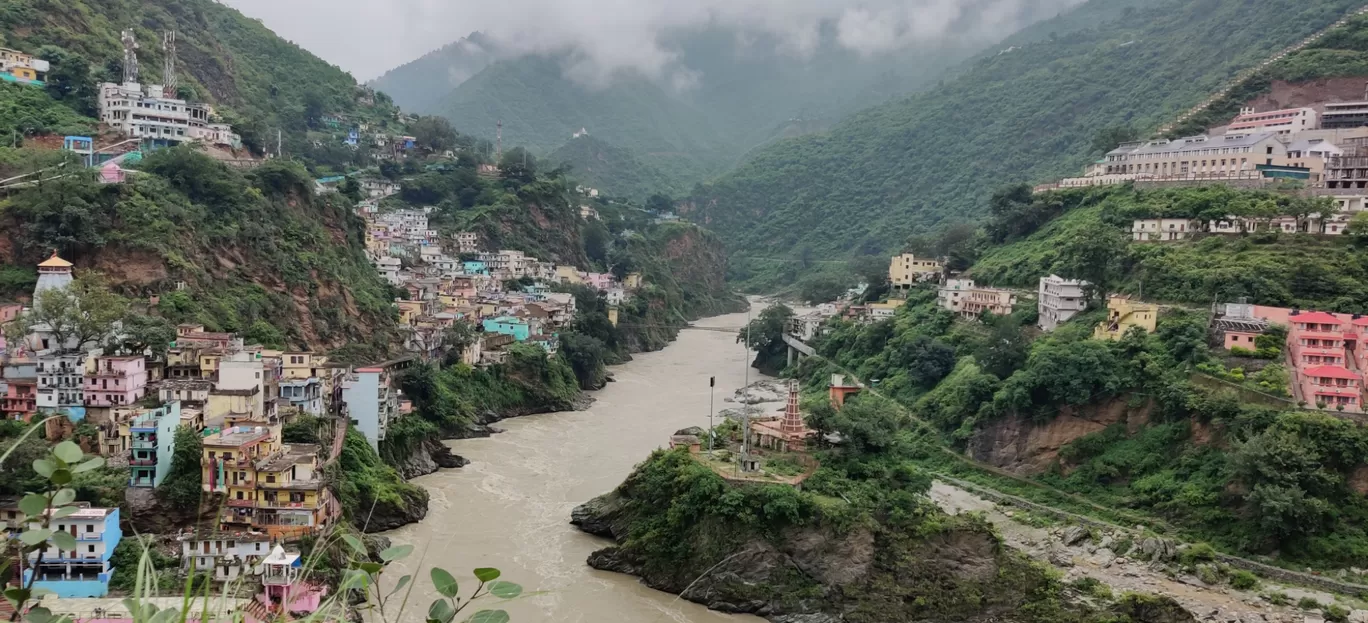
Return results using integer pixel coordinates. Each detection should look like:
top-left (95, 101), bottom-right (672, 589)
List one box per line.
top-left (98, 82), bottom-right (242, 149)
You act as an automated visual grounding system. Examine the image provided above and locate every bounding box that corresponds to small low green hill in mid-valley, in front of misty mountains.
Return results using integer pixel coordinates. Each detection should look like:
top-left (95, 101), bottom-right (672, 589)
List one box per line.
top-left (546, 136), bottom-right (688, 201)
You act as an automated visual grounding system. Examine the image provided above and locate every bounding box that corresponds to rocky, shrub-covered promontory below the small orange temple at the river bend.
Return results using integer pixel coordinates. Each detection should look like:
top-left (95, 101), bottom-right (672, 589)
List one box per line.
top-left (572, 452), bottom-right (1194, 623)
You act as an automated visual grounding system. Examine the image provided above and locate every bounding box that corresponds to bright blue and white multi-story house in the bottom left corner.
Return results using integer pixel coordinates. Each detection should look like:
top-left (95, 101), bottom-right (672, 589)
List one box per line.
top-left (23, 508), bottom-right (123, 598)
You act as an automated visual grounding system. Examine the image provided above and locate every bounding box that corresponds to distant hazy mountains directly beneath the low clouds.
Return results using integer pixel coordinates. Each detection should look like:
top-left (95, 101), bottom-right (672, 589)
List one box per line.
top-left (371, 0), bottom-right (1099, 193)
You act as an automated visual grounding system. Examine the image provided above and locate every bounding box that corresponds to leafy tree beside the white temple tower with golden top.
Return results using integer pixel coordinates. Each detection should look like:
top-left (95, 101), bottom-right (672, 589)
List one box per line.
top-left (5, 274), bottom-right (129, 349)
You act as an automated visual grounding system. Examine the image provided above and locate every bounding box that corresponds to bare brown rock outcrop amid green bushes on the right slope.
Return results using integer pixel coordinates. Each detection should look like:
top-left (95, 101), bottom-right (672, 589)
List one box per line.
top-left (967, 397), bottom-right (1150, 474)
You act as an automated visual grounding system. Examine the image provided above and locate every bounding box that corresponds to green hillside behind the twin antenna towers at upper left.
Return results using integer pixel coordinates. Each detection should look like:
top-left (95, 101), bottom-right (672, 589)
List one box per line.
top-left (0, 0), bottom-right (397, 153)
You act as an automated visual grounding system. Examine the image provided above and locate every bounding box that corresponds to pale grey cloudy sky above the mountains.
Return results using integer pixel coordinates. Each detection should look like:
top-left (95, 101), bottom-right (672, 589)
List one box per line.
top-left (222, 0), bottom-right (1082, 81)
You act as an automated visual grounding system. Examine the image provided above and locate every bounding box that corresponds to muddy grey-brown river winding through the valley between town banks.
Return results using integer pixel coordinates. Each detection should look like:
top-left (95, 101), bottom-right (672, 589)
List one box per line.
top-left (386, 307), bottom-right (762, 623)
